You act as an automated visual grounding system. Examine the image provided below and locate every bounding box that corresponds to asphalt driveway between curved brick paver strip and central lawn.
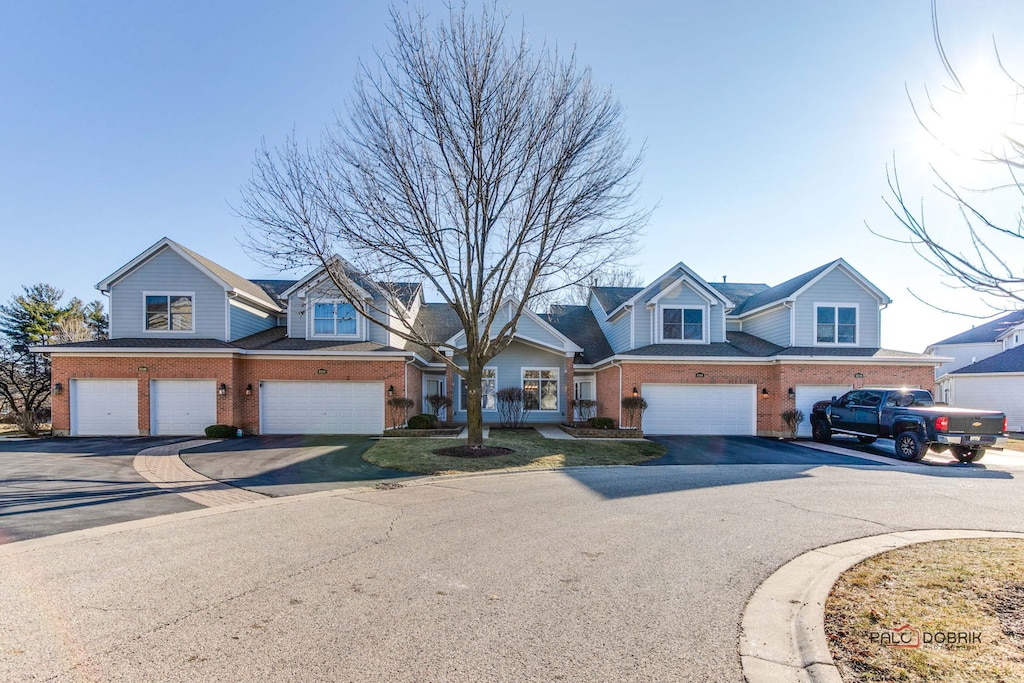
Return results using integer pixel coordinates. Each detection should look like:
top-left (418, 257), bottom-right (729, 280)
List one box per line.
top-left (179, 435), bottom-right (416, 497)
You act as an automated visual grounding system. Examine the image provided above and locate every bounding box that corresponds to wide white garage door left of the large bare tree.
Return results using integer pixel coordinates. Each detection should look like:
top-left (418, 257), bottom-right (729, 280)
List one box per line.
top-left (259, 381), bottom-right (384, 434)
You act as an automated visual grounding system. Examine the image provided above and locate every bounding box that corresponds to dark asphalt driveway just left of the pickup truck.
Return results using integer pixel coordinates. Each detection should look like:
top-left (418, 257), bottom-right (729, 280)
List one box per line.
top-left (644, 436), bottom-right (880, 466)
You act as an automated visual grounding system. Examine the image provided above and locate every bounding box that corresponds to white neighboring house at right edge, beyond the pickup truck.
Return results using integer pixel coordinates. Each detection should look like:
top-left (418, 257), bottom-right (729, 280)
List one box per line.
top-left (926, 310), bottom-right (1024, 431)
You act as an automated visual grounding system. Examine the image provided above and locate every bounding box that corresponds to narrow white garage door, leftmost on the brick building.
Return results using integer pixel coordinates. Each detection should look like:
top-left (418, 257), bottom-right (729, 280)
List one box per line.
top-left (71, 380), bottom-right (138, 436)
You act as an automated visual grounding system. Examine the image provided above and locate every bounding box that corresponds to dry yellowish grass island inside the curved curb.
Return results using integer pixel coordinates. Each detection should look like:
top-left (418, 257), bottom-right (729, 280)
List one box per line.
top-left (825, 539), bottom-right (1024, 683)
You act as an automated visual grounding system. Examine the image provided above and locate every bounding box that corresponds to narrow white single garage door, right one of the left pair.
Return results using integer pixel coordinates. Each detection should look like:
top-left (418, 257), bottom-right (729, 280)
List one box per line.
top-left (150, 380), bottom-right (217, 436)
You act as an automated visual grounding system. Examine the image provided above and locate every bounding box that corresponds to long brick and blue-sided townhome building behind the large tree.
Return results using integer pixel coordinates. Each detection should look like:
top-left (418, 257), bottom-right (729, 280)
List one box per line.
top-left (34, 239), bottom-right (941, 436)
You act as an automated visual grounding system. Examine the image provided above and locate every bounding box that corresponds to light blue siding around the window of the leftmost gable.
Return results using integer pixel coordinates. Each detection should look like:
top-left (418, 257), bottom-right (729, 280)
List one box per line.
top-left (111, 247), bottom-right (227, 340)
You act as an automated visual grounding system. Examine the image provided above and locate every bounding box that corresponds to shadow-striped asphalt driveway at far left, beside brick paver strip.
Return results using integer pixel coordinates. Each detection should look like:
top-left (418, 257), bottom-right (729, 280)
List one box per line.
top-left (0, 437), bottom-right (202, 544)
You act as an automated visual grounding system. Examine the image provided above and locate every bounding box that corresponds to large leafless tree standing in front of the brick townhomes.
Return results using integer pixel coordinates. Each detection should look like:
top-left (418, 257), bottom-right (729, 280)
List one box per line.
top-left (239, 5), bottom-right (647, 446)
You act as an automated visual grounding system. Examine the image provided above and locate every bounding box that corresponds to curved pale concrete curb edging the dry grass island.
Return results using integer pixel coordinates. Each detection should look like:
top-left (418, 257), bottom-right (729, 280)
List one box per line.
top-left (739, 529), bottom-right (1024, 683)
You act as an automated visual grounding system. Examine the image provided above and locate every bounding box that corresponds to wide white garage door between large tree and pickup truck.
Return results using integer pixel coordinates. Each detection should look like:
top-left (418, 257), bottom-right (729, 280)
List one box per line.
top-left (643, 384), bottom-right (758, 435)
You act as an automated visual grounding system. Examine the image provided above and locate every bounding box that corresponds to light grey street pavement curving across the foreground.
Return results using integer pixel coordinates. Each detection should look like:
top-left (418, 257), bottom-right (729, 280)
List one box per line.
top-left (0, 459), bottom-right (1024, 682)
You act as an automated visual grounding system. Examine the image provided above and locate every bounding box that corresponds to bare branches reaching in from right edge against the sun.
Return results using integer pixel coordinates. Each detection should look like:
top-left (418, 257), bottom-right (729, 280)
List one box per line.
top-left (872, 0), bottom-right (1024, 317)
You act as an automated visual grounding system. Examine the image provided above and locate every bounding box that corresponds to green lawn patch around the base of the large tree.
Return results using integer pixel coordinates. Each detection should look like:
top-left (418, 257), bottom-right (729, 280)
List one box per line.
top-left (362, 429), bottom-right (665, 474)
